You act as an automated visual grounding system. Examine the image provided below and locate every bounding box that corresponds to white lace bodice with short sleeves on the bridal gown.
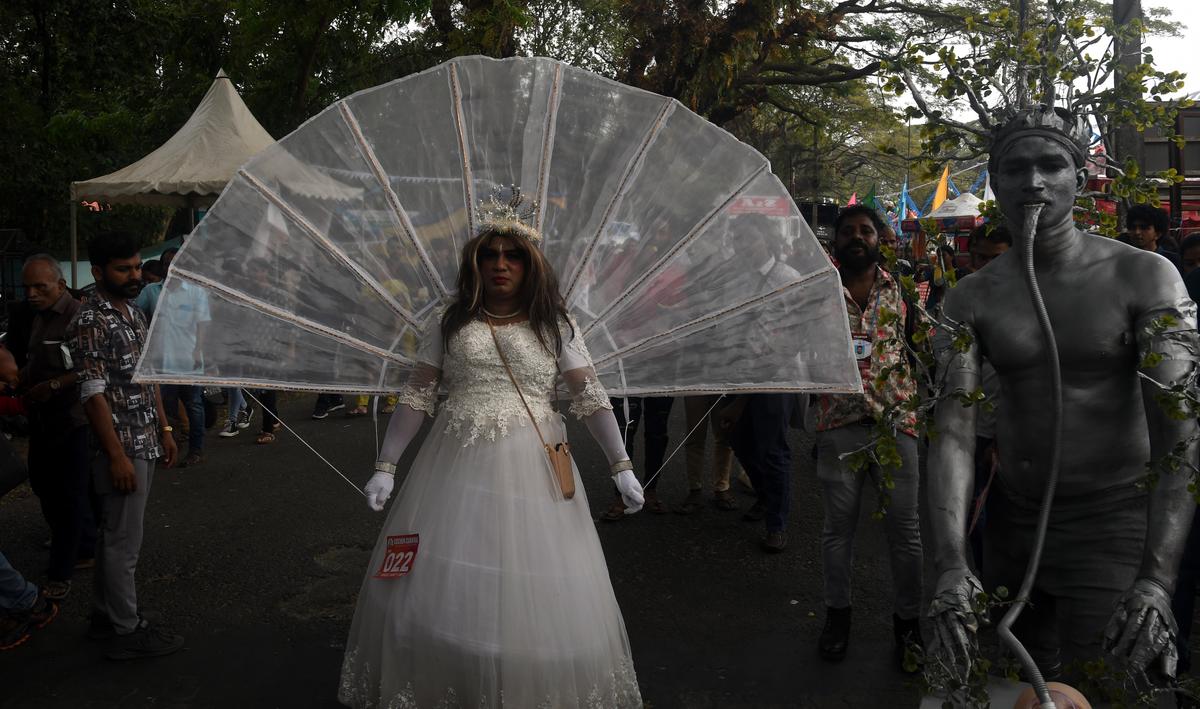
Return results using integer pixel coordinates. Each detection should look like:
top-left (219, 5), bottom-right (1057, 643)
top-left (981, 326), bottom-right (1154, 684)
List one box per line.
top-left (400, 320), bottom-right (612, 445)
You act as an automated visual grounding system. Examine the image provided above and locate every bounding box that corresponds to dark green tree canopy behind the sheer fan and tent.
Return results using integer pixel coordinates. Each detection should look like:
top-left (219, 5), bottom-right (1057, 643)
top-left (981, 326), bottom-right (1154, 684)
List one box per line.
top-left (0, 0), bottom-right (1180, 255)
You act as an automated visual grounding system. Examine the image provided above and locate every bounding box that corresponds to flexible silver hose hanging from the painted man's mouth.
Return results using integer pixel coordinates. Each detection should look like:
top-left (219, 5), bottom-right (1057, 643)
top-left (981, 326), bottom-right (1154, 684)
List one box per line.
top-left (998, 204), bottom-right (1062, 709)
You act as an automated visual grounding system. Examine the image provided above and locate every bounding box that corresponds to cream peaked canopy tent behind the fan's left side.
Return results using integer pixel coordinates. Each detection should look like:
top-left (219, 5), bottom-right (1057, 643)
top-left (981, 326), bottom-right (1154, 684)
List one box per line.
top-left (71, 71), bottom-right (275, 287)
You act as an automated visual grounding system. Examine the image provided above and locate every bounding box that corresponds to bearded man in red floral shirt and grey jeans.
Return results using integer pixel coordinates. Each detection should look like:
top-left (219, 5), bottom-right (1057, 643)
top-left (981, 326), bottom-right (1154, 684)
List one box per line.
top-left (816, 205), bottom-right (923, 662)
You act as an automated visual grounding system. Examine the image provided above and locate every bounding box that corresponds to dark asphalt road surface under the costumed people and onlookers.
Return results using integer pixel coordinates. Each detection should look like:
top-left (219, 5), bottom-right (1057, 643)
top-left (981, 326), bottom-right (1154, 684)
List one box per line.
top-left (0, 395), bottom-right (929, 709)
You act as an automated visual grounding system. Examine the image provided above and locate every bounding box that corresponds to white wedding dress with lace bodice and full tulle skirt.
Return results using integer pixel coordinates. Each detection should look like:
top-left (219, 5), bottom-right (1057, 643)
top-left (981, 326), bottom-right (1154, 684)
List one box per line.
top-left (338, 322), bottom-right (642, 709)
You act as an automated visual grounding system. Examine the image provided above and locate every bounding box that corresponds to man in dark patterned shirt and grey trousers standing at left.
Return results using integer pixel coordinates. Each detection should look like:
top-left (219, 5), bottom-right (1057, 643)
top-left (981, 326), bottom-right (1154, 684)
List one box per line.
top-left (67, 233), bottom-right (184, 660)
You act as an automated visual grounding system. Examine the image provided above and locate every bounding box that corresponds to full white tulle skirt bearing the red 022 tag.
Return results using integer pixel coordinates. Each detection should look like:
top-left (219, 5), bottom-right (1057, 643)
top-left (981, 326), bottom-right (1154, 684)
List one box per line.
top-left (338, 417), bottom-right (642, 709)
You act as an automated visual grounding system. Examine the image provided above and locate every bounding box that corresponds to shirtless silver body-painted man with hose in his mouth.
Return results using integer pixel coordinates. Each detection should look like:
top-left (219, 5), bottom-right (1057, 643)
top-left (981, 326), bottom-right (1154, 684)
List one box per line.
top-left (926, 107), bottom-right (1196, 679)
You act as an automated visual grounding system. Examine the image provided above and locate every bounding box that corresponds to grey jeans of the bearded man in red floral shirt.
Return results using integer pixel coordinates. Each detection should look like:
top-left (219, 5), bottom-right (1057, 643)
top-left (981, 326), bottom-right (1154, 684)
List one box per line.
top-left (817, 423), bottom-right (923, 620)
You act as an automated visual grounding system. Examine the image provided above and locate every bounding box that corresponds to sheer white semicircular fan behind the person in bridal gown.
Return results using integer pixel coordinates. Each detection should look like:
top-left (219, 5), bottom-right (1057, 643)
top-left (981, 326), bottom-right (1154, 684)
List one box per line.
top-left (137, 56), bottom-right (860, 396)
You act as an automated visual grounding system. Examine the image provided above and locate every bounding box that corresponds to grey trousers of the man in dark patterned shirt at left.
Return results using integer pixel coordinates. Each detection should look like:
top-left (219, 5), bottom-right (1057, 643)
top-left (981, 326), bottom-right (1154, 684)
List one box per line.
top-left (92, 453), bottom-right (155, 635)
